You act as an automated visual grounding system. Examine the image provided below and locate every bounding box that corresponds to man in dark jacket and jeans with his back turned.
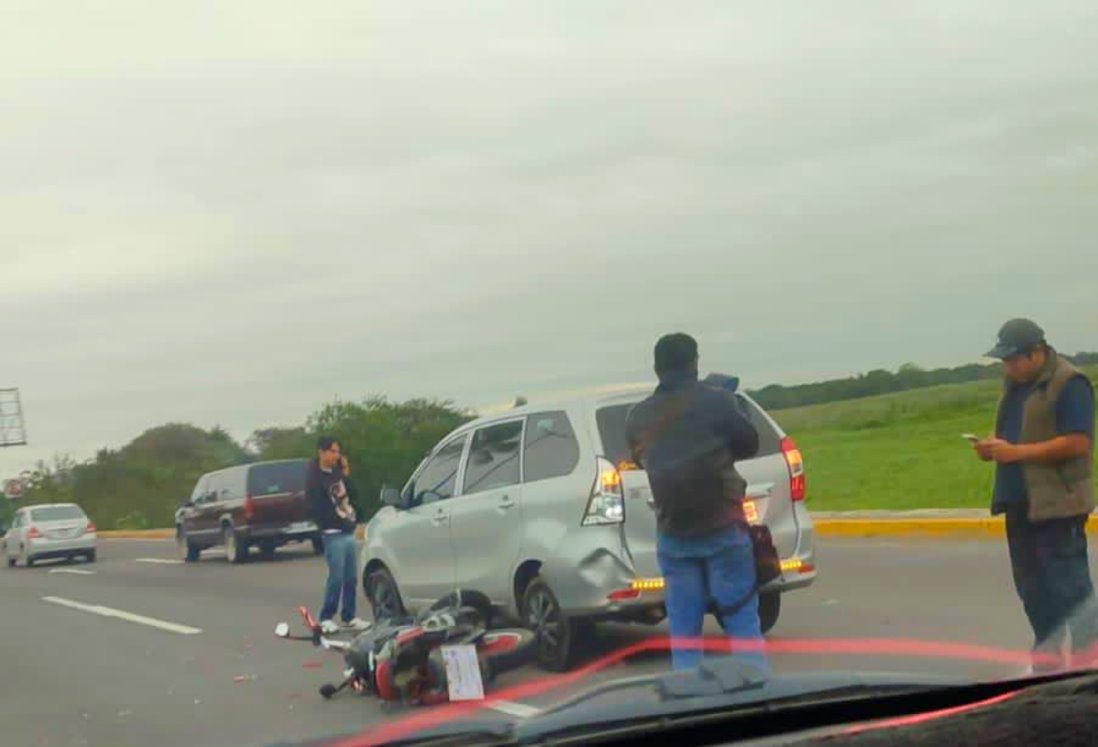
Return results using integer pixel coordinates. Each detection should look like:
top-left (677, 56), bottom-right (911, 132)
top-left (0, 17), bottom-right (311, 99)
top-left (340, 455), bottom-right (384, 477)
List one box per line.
top-left (626, 334), bottom-right (768, 670)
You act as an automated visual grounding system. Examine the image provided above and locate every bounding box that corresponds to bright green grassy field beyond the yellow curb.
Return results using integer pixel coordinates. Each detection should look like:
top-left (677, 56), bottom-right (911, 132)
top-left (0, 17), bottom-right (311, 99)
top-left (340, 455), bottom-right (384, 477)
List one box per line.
top-left (772, 368), bottom-right (1098, 511)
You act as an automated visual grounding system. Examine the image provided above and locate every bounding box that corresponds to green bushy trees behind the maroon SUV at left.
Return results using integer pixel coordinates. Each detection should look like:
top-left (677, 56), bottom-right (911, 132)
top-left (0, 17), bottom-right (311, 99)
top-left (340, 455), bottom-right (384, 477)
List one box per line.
top-left (7, 397), bottom-right (472, 529)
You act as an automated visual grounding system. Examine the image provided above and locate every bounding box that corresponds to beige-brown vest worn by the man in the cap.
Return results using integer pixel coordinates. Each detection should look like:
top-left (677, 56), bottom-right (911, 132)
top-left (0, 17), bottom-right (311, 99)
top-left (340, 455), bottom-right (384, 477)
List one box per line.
top-left (999, 348), bottom-right (1095, 522)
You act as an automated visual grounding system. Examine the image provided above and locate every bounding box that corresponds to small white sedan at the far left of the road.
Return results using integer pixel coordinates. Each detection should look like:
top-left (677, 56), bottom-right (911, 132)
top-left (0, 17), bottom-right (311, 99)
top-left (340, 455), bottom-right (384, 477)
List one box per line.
top-left (3, 503), bottom-right (96, 568)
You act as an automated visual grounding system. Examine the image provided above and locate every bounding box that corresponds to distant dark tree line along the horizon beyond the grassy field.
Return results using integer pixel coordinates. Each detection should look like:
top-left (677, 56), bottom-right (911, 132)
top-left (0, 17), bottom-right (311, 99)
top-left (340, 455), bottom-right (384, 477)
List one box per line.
top-left (748, 353), bottom-right (1098, 410)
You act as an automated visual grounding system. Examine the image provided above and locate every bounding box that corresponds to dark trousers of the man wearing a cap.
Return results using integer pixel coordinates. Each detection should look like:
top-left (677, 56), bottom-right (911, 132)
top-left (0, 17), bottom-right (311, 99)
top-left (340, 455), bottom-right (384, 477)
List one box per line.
top-left (1007, 510), bottom-right (1098, 668)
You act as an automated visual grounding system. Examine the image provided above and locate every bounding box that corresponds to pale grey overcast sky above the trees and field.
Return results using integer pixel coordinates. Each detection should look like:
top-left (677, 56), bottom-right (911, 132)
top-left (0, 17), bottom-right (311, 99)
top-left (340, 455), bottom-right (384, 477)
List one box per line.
top-left (0, 0), bottom-right (1098, 476)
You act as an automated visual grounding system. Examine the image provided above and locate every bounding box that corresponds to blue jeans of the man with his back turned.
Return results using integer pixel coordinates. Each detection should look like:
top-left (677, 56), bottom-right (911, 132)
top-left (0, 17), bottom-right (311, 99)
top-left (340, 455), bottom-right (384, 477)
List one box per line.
top-left (657, 524), bottom-right (770, 672)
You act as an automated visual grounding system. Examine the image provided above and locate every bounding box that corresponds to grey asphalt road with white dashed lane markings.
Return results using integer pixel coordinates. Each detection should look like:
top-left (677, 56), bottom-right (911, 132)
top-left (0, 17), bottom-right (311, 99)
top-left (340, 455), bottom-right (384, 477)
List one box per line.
top-left (0, 539), bottom-right (1089, 747)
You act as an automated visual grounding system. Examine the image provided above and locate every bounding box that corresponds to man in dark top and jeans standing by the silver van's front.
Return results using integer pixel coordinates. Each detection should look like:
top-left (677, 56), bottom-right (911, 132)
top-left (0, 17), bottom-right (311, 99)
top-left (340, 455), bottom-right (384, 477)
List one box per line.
top-left (305, 436), bottom-right (368, 633)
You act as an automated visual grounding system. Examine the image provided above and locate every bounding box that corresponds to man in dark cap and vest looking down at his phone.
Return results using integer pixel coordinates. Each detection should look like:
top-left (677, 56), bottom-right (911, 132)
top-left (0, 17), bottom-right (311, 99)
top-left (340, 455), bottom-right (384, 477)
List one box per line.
top-left (974, 319), bottom-right (1098, 671)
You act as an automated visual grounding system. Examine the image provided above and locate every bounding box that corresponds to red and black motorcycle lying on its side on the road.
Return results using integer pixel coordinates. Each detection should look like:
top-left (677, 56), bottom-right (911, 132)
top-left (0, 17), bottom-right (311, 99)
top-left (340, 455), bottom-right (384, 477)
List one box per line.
top-left (275, 591), bottom-right (534, 705)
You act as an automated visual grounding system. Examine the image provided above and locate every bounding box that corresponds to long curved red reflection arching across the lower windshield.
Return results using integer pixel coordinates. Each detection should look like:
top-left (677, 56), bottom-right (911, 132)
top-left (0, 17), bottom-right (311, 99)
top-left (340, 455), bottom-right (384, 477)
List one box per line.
top-left (334, 636), bottom-right (1058, 747)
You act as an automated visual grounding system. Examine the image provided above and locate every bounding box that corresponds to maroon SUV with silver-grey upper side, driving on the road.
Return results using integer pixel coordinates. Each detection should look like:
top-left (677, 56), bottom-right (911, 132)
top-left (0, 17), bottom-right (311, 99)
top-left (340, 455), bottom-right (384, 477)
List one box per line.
top-left (176, 459), bottom-right (324, 562)
